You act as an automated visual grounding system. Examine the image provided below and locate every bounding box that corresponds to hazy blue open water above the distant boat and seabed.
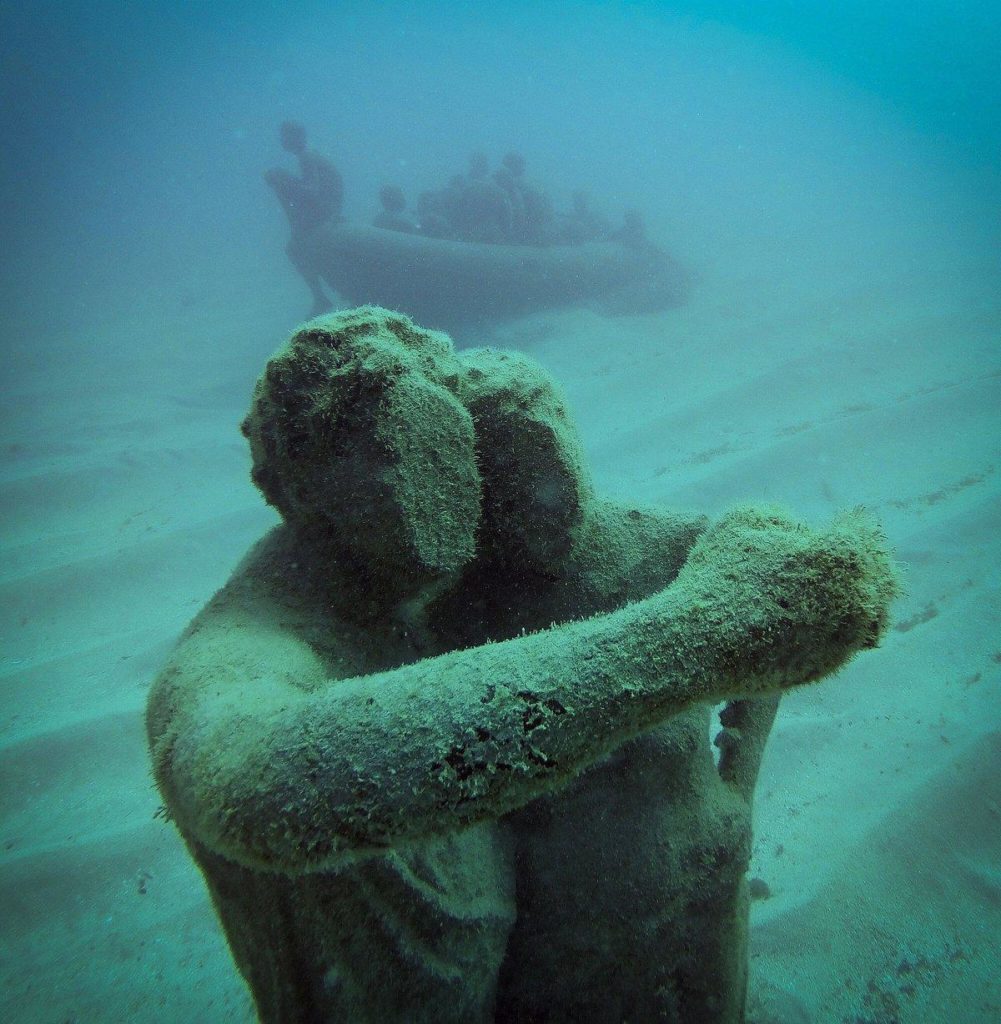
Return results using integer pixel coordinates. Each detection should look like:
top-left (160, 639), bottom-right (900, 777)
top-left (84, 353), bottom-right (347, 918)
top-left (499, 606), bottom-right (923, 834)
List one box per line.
top-left (2, 0), bottom-right (1001, 329)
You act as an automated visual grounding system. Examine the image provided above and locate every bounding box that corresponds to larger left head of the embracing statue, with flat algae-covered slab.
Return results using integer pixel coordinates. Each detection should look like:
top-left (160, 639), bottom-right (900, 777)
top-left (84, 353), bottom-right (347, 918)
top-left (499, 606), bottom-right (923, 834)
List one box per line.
top-left (243, 309), bottom-right (481, 589)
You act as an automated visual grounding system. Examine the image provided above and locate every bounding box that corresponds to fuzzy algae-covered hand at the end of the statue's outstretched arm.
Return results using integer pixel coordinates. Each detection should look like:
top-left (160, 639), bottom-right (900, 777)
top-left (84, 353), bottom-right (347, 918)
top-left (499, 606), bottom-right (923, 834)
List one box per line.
top-left (668, 509), bottom-right (897, 694)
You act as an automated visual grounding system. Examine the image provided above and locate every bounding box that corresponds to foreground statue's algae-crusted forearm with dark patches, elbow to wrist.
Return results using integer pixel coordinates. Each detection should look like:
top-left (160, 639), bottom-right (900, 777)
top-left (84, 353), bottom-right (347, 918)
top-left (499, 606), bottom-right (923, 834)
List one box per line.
top-left (155, 602), bottom-right (708, 872)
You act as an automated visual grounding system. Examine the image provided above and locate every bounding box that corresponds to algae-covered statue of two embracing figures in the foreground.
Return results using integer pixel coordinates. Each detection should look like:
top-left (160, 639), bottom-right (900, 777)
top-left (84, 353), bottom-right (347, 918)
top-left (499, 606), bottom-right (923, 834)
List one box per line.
top-left (148, 308), bottom-right (895, 1024)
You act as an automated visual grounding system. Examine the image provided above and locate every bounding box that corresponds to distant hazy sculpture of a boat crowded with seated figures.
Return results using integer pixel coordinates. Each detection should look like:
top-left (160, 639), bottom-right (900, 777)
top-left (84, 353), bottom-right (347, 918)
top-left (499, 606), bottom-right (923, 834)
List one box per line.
top-left (264, 121), bottom-right (690, 333)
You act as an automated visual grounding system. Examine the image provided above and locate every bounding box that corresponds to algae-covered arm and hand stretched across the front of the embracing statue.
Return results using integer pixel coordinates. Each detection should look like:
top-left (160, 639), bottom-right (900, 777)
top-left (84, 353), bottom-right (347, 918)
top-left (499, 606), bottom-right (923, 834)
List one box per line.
top-left (149, 510), bottom-right (895, 873)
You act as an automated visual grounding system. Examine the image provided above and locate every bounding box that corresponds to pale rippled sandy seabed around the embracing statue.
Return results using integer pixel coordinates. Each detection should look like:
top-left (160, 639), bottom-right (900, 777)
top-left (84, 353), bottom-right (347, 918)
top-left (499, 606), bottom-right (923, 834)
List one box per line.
top-left (0, 195), bottom-right (1001, 1024)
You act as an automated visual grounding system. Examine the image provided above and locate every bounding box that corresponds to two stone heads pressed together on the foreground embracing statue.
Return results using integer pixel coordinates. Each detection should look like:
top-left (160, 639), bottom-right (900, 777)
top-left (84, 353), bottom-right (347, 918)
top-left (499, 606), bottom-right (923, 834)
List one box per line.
top-left (243, 307), bottom-right (590, 597)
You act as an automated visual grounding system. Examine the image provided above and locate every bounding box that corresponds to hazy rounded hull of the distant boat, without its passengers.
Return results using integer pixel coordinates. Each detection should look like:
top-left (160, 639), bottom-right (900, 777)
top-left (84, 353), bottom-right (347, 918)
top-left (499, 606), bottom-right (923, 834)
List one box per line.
top-left (301, 222), bottom-right (688, 332)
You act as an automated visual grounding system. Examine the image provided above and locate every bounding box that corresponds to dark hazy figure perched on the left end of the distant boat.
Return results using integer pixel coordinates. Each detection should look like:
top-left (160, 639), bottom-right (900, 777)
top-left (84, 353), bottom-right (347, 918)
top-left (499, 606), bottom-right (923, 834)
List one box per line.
top-left (264, 121), bottom-right (344, 316)
